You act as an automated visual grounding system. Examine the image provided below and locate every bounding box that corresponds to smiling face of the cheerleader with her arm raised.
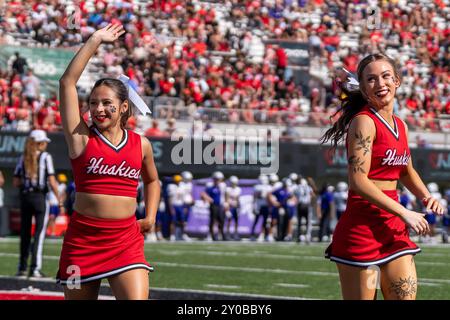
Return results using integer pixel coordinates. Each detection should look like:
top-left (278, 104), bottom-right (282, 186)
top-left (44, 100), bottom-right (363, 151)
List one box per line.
top-left (89, 85), bottom-right (128, 129)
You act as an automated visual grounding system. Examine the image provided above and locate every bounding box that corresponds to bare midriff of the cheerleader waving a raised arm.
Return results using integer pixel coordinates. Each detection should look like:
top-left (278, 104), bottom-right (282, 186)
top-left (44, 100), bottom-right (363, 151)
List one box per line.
top-left (74, 192), bottom-right (136, 219)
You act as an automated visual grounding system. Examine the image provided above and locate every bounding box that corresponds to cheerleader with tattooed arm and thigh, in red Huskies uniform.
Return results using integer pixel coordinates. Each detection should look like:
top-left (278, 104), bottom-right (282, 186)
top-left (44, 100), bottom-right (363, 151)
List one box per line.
top-left (322, 53), bottom-right (443, 300)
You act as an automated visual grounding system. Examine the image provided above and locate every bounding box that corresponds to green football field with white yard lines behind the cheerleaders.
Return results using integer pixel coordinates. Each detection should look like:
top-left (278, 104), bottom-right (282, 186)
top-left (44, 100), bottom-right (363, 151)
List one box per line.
top-left (0, 238), bottom-right (450, 300)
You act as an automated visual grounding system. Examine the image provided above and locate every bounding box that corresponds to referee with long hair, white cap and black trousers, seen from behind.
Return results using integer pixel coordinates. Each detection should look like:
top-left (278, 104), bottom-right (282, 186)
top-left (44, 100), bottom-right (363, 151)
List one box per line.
top-left (13, 130), bottom-right (62, 278)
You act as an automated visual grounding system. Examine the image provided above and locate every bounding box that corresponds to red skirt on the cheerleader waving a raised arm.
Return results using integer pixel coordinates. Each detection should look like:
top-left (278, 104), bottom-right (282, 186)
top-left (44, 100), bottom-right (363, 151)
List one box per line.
top-left (56, 212), bottom-right (153, 285)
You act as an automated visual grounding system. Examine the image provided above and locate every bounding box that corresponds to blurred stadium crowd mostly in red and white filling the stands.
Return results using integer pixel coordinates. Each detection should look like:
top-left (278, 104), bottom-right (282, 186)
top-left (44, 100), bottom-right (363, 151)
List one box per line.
top-left (0, 0), bottom-right (450, 136)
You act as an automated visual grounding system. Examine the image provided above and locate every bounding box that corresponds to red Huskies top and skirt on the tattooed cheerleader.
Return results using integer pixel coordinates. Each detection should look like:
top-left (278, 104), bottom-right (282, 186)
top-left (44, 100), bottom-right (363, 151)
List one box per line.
top-left (326, 106), bottom-right (420, 267)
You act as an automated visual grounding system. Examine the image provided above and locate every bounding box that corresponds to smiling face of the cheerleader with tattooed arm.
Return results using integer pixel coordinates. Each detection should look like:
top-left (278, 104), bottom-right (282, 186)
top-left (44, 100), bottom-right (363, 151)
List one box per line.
top-left (360, 60), bottom-right (400, 108)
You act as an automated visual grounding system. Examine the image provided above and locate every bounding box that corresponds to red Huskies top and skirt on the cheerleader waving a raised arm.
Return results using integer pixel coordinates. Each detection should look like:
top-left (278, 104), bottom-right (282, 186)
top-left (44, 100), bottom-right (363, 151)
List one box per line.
top-left (56, 127), bottom-right (153, 285)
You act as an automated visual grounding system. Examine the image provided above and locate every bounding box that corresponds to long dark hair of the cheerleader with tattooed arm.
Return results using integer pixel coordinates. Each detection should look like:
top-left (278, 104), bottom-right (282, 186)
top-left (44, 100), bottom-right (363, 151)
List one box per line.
top-left (320, 53), bottom-right (401, 150)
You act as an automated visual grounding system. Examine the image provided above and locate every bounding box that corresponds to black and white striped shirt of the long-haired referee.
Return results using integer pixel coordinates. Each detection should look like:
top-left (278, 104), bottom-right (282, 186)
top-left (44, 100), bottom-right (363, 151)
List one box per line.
top-left (14, 152), bottom-right (55, 193)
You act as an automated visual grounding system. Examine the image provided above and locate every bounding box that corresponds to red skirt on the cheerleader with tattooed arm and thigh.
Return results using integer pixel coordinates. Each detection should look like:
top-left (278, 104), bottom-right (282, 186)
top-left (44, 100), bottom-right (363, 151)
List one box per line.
top-left (325, 190), bottom-right (420, 267)
